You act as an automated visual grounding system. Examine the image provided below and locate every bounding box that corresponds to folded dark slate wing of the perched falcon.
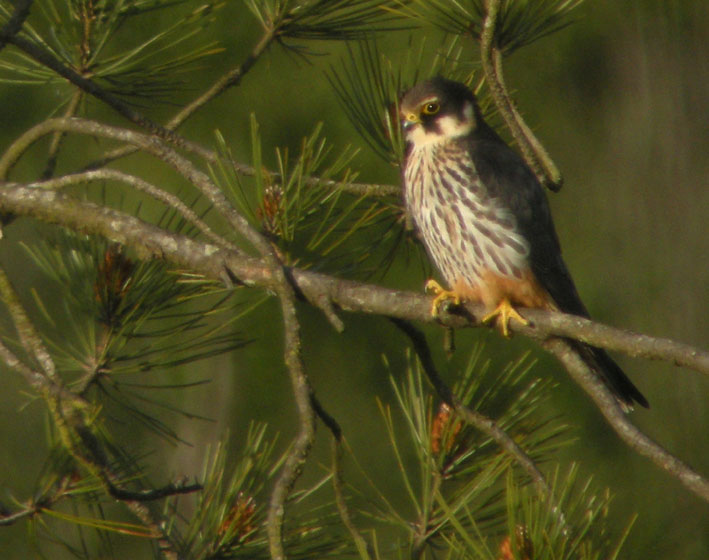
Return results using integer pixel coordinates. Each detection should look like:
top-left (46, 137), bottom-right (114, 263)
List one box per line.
top-left (470, 129), bottom-right (588, 317)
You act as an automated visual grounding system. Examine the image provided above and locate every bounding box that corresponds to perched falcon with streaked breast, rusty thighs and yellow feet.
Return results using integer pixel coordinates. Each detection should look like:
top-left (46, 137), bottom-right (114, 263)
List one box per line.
top-left (399, 76), bottom-right (649, 411)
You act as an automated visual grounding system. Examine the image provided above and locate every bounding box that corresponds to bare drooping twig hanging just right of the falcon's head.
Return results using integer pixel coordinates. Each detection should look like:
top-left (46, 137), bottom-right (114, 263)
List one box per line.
top-left (480, 0), bottom-right (563, 192)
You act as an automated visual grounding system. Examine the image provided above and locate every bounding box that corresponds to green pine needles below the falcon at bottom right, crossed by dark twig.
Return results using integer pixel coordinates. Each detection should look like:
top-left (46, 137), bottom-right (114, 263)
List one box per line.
top-left (334, 345), bottom-right (619, 560)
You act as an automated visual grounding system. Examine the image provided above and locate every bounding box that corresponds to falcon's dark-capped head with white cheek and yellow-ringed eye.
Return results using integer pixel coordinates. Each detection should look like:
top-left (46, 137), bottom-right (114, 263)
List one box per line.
top-left (400, 77), bottom-right (479, 146)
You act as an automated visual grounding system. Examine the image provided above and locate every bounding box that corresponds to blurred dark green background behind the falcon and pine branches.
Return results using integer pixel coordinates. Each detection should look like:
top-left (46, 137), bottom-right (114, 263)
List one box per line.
top-left (0, 0), bottom-right (709, 560)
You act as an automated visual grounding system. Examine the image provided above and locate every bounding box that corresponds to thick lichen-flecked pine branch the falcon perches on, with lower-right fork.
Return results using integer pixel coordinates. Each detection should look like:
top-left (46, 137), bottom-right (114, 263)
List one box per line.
top-left (0, 184), bottom-right (709, 501)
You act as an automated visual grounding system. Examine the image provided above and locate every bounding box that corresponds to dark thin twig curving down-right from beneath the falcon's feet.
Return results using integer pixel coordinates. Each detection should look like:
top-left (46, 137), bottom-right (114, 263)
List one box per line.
top-left (391, 318), bottom-right (551, 497)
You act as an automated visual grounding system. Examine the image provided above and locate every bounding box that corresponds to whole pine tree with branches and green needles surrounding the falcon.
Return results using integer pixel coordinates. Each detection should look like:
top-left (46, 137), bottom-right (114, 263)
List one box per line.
top-left (0, 0), bottom-right (709, 560)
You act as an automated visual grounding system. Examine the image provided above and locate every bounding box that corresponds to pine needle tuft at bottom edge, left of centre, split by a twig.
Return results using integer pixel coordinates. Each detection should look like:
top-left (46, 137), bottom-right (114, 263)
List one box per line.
top-left (173, 424), bottom-right (346, 560)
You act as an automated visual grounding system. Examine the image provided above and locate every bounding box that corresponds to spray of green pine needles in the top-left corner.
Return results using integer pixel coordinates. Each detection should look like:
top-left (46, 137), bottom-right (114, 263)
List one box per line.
top-left (0, 0), bottom-right (224, 99)
